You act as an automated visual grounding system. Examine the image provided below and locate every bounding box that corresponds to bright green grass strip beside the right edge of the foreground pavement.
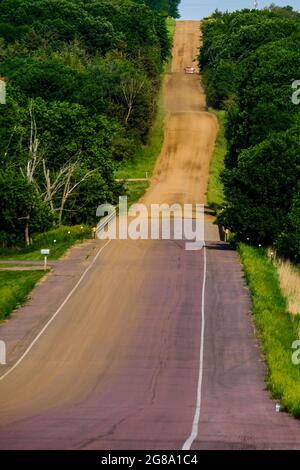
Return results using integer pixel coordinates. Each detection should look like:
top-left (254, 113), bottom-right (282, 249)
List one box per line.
top-left (239, 243), bottom-right (300, 418)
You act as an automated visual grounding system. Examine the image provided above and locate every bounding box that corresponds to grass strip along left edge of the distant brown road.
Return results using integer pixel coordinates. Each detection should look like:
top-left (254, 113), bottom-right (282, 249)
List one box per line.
top-left (116, 18), bottom-right (176, 205)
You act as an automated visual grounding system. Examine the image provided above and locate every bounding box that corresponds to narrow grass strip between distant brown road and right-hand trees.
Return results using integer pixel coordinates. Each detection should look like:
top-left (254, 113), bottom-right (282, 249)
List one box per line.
top-left (207, 108), bottom-right (227, 210)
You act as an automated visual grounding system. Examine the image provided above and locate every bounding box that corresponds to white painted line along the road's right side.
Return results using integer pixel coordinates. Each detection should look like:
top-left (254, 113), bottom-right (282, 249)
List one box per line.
top-left (182, 244), bottom-right (207, 450)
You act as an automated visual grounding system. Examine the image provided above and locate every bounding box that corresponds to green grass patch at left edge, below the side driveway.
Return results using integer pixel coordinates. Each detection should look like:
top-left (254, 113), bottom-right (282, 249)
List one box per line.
top-left (0, 271), bottom-right (45, 322)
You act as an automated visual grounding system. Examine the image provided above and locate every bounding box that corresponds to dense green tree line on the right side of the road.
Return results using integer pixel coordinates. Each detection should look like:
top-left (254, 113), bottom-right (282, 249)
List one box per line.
top-left (200, 6), bottom-right (300, 262)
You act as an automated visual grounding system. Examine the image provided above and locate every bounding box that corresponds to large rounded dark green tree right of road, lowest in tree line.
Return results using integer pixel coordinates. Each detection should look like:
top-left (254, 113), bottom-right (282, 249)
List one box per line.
top-left (220, 126), bottom-right (300, 244)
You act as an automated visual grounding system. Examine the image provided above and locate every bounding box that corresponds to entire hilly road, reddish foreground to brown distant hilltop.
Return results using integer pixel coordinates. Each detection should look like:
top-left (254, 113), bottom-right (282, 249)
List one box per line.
top-left (0, 22), bottom-right (300, 450)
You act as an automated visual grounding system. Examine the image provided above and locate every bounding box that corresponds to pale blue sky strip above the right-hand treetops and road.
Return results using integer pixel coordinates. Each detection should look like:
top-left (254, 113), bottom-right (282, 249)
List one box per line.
top-left (180, 0), bottom-right (300, 20)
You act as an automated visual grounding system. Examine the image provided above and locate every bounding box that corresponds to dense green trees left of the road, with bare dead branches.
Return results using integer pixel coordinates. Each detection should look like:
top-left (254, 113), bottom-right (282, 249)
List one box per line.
top-left (0, 0), bottom-right (179, 245)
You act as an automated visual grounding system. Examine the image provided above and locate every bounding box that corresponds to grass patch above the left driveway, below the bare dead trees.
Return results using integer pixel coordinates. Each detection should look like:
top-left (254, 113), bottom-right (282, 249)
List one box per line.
top-left (0, 225), bottom-right (91, 263)
